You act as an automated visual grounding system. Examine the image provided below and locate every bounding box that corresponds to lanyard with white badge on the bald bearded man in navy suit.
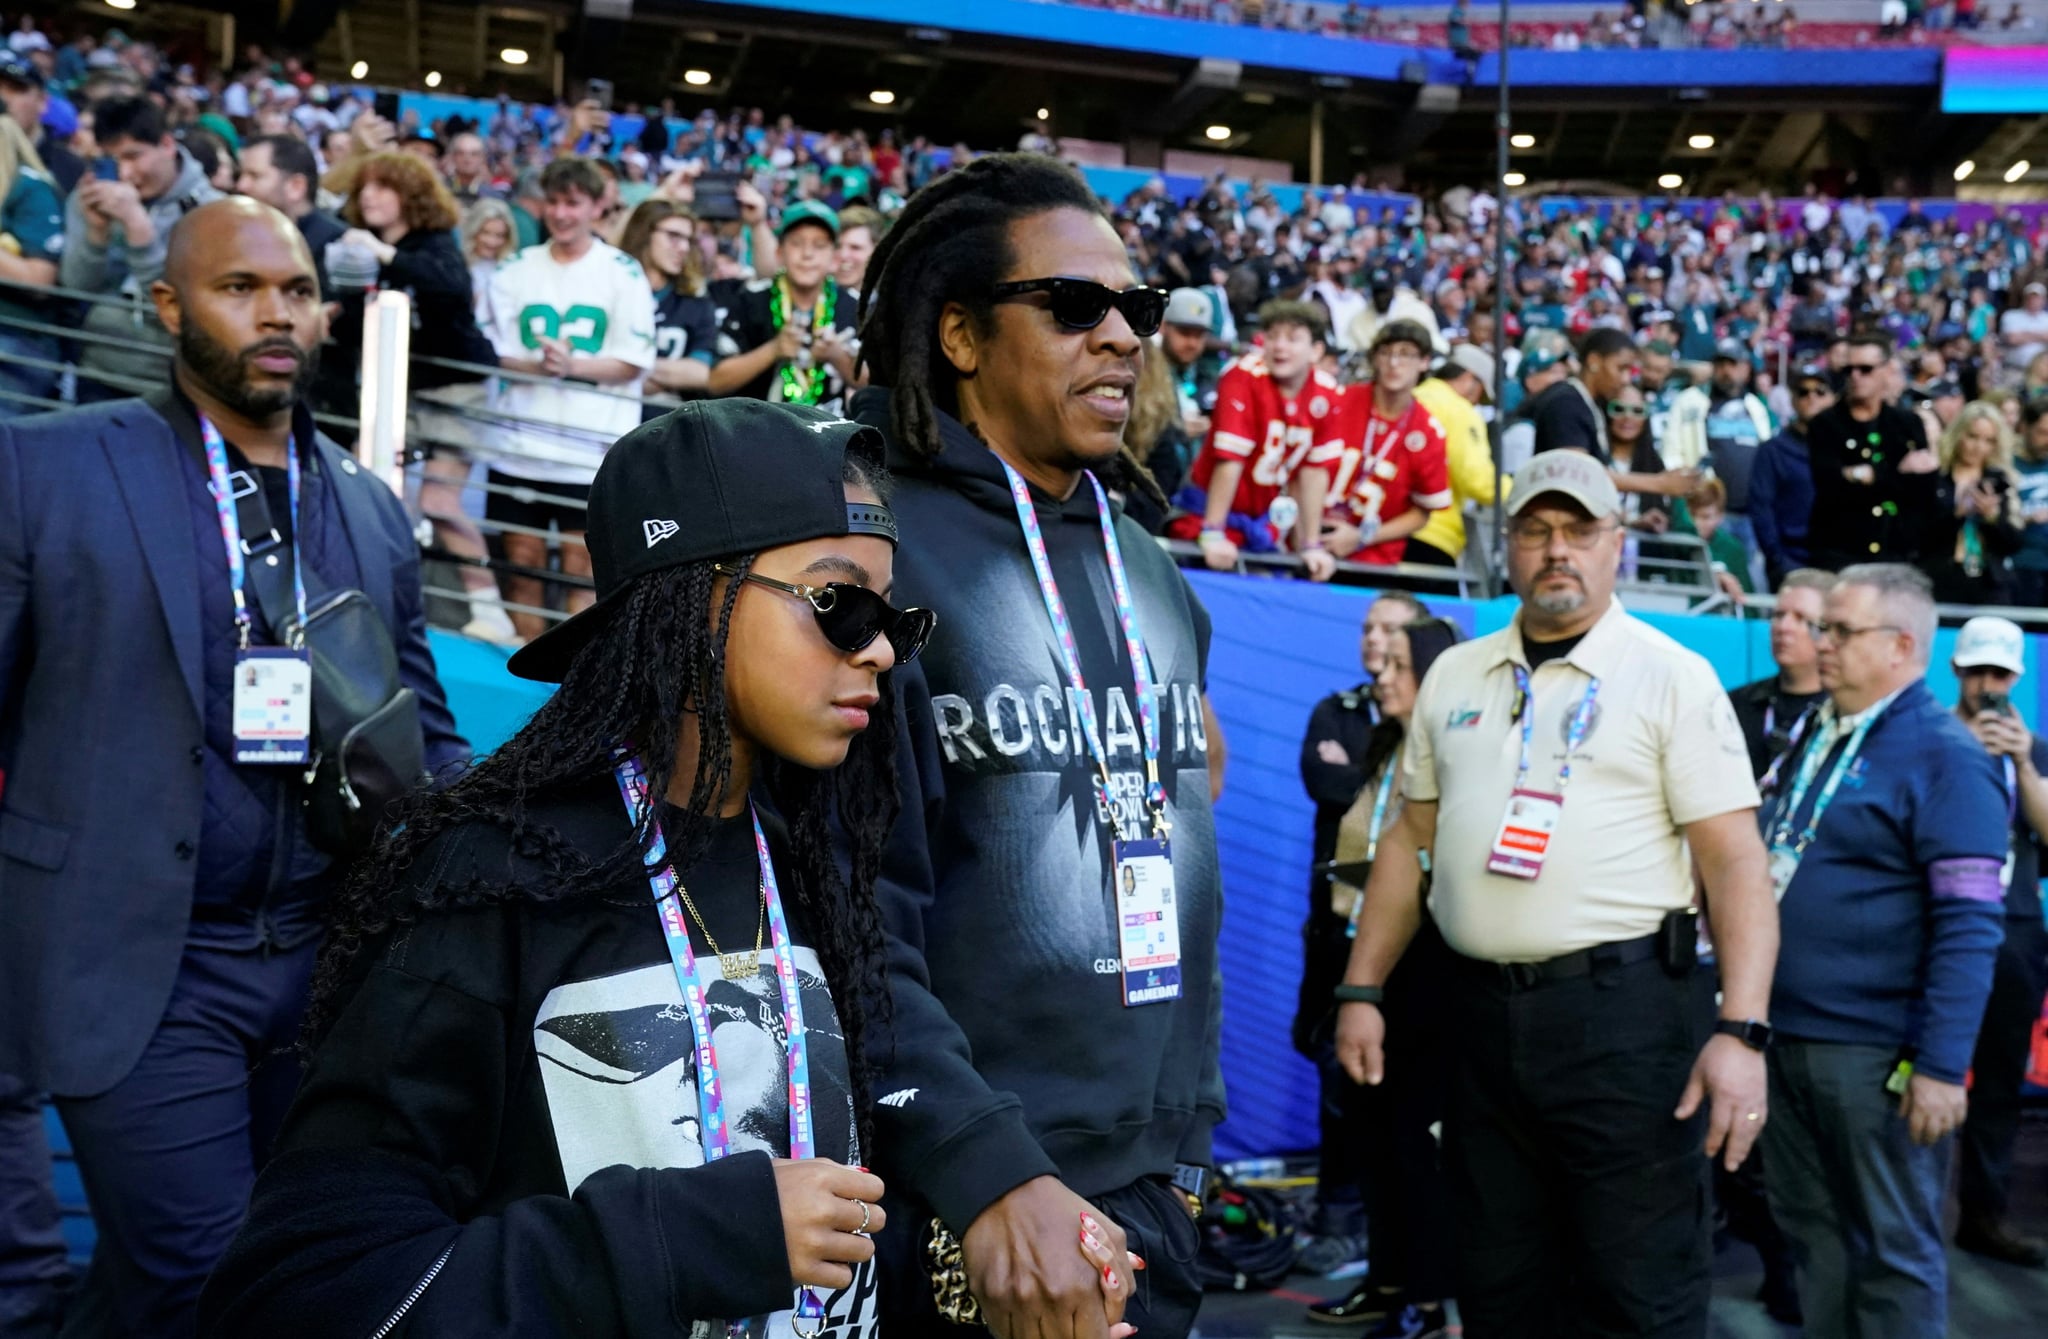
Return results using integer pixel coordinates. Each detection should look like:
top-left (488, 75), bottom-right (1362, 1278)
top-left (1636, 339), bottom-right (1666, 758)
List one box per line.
top-left (199, 416), bottom-right (313, 764)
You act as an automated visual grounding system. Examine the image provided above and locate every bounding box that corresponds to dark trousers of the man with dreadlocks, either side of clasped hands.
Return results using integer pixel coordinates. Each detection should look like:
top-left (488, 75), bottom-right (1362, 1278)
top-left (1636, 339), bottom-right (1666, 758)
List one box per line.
top-left (874, 1179), bottom-right (1202, 1339)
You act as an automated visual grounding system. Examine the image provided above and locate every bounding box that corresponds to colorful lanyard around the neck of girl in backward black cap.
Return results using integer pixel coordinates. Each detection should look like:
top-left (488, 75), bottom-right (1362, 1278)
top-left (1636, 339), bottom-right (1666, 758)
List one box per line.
top-left (612, 749), bottom-right (825, 1335)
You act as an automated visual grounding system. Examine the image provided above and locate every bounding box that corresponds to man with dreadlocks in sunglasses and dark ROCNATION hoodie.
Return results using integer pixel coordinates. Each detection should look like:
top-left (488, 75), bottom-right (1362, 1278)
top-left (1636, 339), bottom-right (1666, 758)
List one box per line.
top-left (854, 154), bottom-right (1223, 1339)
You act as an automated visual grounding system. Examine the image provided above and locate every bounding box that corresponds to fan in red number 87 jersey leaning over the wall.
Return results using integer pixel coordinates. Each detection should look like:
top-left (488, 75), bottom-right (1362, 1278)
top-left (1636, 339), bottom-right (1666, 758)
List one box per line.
top-left (1167, 301), bottom-right (1343, 581)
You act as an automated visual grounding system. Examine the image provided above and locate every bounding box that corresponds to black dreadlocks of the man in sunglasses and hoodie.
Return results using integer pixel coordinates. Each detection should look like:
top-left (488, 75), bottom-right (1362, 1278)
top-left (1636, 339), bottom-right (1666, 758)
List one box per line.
top-left (860, 154), bottom-right (1167, 508)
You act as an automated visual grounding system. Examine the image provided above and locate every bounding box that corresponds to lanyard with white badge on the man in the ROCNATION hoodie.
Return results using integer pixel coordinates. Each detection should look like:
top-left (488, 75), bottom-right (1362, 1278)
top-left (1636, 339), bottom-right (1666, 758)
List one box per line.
top-left (1004, 461), bottom-right (1180, 1007)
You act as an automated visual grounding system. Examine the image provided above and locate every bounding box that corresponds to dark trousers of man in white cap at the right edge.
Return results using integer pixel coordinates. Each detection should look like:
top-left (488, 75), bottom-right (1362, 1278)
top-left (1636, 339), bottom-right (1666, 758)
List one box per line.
top-left (1958, 917), bottom-right (2048, 1220)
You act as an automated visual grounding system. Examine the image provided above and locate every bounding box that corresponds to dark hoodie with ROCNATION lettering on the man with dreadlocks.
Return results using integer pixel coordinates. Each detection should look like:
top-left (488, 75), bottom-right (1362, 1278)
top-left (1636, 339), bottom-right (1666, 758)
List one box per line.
top-left (854, 391), bottom-right (1223, 1233)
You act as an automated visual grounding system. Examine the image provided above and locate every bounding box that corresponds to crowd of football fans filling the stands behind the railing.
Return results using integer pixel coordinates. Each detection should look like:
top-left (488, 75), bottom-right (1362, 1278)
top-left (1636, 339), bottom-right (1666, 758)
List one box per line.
top-left (0, 13), bottom-right (2048, 641)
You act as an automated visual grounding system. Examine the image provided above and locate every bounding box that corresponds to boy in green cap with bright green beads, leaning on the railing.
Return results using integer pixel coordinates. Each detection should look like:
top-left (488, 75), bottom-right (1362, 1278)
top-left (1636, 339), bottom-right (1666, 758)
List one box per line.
top-left (711, 201), bottom-right (860, 409)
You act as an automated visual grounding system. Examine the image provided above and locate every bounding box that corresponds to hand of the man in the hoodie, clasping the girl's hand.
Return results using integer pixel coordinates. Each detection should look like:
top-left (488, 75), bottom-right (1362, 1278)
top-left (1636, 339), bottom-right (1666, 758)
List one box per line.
top-left (961, 1177), bottom-right (1128, 1339)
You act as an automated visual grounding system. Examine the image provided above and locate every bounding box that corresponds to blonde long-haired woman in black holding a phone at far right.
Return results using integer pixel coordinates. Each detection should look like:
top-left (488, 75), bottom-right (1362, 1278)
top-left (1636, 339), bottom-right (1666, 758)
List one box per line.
top-left (1921, 399), bottom-right (2021, 604)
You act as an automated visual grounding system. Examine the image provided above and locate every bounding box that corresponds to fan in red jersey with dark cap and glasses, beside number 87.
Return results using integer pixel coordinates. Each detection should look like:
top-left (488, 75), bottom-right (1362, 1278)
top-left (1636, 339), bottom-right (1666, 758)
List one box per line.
top-left (1321, 321), bottom-right (1450, 563)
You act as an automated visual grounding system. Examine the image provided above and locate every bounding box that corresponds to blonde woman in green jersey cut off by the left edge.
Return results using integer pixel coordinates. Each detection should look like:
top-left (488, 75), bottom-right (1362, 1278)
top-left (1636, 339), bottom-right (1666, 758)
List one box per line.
top-left (0, 117), bottom-right (63, 418)
